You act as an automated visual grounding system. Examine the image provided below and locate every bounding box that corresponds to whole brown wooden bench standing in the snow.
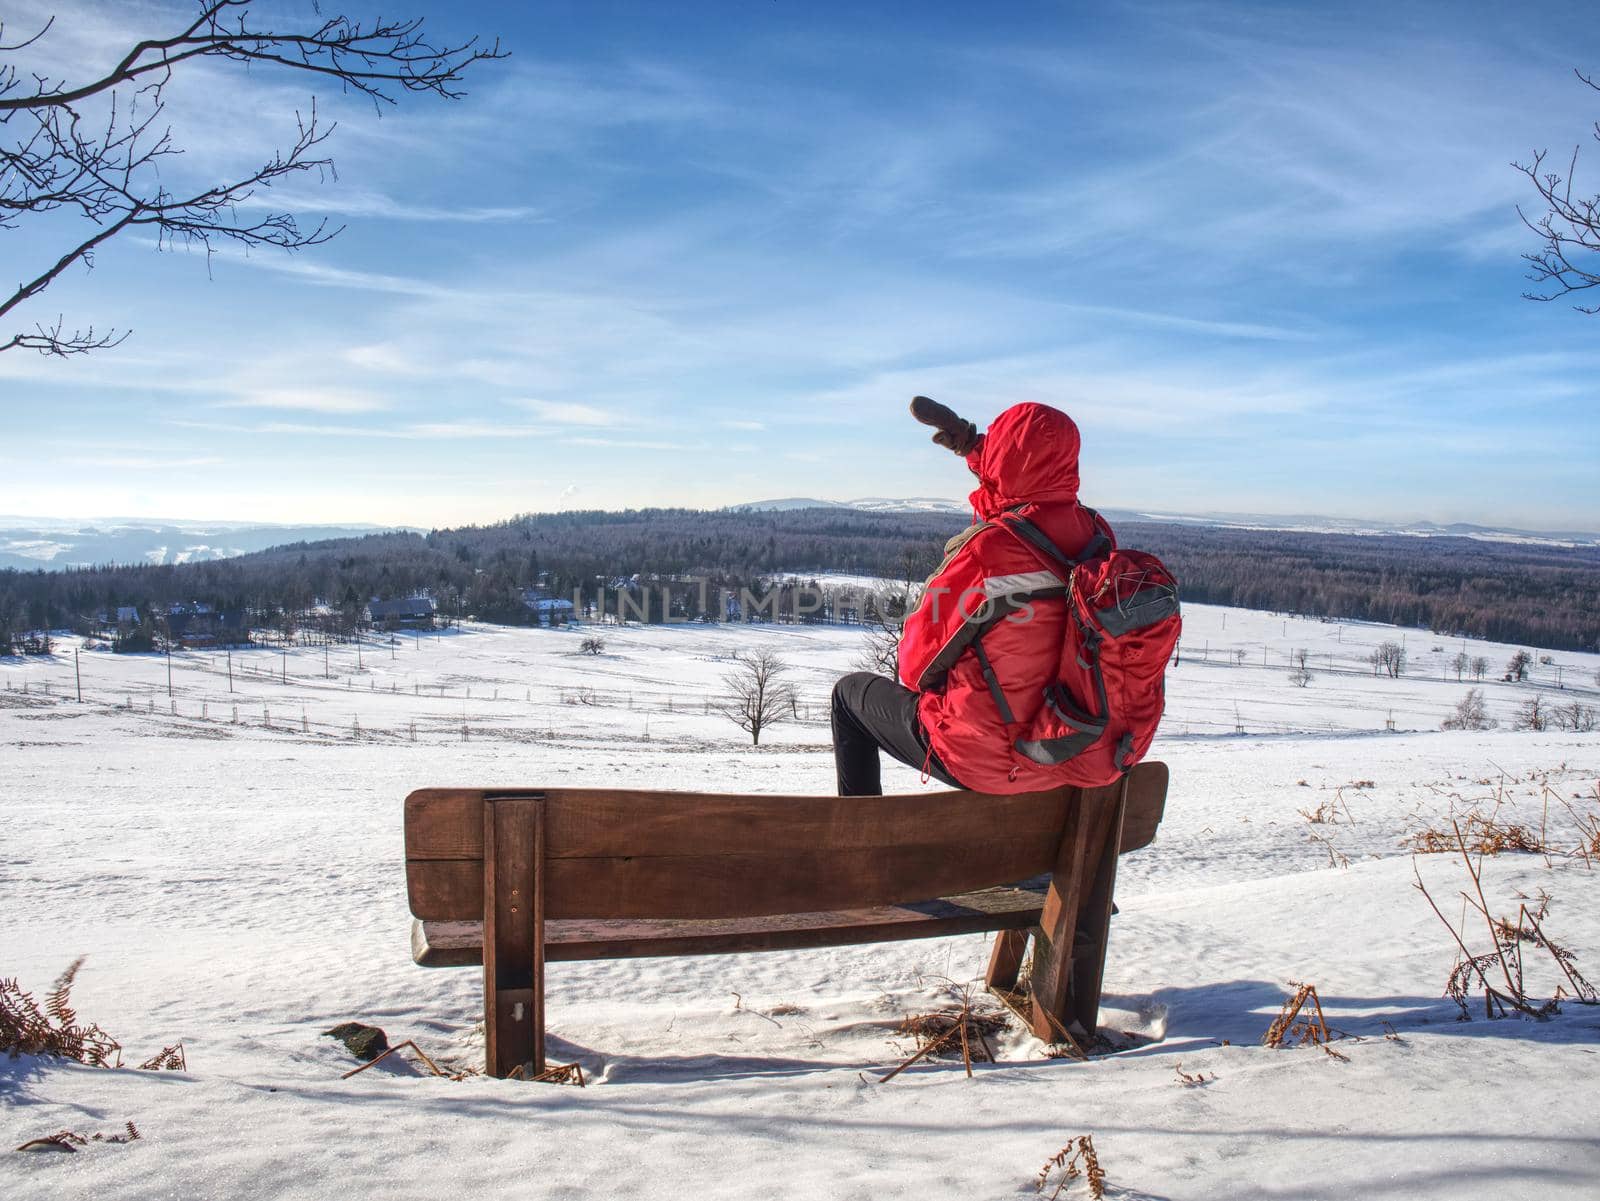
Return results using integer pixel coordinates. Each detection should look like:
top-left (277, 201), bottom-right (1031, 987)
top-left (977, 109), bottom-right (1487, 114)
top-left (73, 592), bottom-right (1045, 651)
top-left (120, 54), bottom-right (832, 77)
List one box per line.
top-left (405, 763), bottom-right (1166, 1078)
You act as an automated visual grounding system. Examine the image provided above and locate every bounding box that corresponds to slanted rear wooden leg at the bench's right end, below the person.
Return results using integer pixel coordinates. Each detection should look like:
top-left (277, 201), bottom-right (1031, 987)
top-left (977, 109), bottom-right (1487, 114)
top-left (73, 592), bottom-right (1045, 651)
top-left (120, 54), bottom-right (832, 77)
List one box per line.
top-left (1030, 784), bottom-right (1125, 1043)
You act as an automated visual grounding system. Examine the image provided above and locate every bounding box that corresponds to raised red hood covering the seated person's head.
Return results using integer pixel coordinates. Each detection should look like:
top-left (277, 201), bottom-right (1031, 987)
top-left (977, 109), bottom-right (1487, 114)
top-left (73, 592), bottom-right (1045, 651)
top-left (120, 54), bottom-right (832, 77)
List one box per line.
top-left (966, 401), bottom-right (1078, 521)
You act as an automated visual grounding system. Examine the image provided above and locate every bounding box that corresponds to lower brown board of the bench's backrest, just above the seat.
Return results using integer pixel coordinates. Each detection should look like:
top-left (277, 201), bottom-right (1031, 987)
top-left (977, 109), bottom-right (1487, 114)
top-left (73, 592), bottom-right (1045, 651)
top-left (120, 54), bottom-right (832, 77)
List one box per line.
top-left (406, 832), bottom-right (1054, 921)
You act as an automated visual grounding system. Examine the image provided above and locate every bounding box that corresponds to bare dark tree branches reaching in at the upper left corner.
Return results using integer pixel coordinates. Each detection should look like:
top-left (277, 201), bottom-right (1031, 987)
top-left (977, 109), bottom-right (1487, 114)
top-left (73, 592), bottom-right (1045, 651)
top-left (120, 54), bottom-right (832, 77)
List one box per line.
top-left (0, 0), bottom-right (506, 357)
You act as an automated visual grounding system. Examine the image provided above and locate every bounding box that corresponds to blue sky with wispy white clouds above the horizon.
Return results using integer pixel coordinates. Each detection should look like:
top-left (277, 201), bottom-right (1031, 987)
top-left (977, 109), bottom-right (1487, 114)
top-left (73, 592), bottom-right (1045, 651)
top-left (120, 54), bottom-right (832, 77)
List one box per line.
top-left (0, 0), bottom-right (1600, 529)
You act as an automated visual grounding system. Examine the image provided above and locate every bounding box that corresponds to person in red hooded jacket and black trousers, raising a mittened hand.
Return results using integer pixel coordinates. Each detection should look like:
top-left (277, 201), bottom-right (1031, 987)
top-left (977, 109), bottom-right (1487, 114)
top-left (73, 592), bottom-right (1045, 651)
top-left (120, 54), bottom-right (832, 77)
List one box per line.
top-left (832, 397), bottom-right (1114, 796)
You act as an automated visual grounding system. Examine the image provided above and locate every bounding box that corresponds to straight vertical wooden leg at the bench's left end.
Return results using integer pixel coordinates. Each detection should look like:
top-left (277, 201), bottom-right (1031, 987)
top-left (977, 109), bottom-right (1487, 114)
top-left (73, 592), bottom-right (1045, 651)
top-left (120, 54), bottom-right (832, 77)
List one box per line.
top-left (483, 796), bottom-right (544, 1079)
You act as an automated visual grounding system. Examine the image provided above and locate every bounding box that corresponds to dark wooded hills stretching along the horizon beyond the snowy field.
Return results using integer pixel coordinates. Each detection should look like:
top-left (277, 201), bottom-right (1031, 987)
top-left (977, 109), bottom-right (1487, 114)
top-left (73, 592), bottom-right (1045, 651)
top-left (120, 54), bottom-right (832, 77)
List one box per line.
top-left (0, 509), bottom-right (1600, 651)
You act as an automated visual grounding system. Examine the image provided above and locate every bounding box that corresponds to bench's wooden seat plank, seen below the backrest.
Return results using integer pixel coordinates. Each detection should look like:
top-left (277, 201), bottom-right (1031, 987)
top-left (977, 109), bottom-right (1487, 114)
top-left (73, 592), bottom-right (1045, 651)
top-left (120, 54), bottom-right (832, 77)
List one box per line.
top-left (411, 876), bottom-right (1050, 968)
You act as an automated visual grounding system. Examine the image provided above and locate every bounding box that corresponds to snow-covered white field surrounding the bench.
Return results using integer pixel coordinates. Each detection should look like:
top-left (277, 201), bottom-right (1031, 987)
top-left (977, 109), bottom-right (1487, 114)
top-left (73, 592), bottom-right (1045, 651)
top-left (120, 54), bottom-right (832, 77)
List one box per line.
top-left (0, 606), bottom-right (1600, 1201)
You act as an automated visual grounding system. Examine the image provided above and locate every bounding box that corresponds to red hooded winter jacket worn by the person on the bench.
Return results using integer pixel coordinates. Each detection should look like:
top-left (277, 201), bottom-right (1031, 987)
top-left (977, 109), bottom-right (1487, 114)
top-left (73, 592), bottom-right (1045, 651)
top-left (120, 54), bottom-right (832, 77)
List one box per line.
top-left (899, 403), bottom-right (1110, 793)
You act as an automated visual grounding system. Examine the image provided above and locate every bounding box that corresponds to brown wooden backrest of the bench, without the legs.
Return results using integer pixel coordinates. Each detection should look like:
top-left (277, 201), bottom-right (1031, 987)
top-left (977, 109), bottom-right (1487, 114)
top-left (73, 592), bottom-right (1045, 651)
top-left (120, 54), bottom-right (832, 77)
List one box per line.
top-left (405, 763), bottom-right (1166, 921)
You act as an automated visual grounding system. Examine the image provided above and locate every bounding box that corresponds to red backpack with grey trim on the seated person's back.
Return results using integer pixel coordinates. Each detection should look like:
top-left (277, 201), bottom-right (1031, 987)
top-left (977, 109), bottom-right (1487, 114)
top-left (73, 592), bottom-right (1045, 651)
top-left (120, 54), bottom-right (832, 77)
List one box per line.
top-left (995, 512), bottom-right (1182, 787)
